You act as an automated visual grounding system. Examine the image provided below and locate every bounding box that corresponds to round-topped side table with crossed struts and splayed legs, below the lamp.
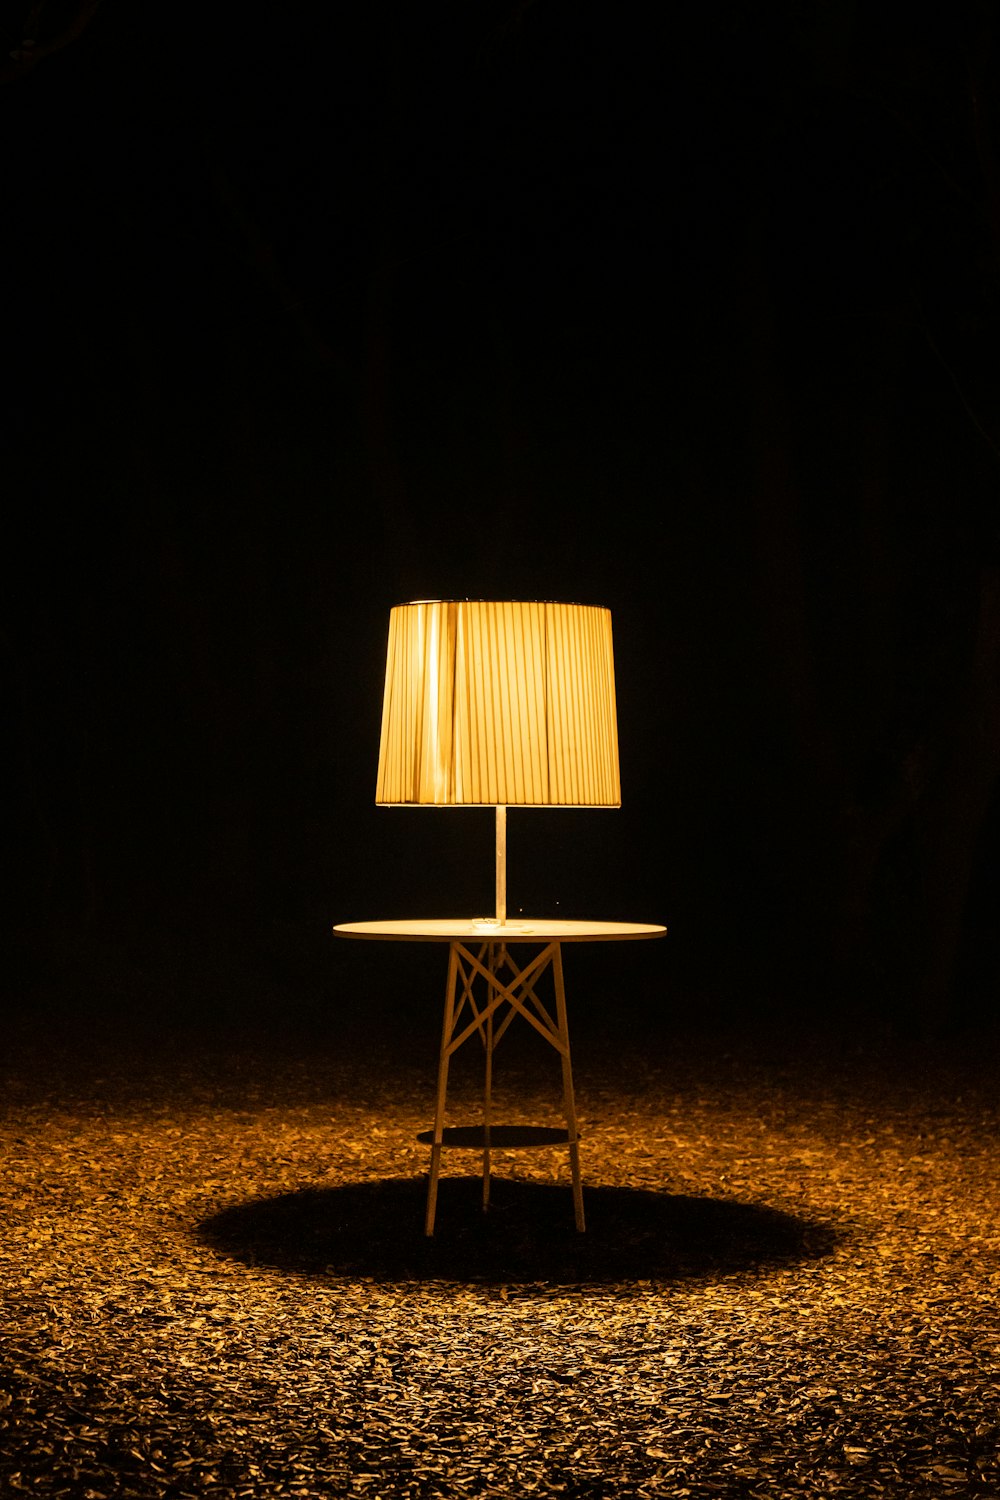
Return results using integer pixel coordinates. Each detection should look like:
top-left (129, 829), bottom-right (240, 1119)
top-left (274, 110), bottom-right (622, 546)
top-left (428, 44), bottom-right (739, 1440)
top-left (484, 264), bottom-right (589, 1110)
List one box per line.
top-left (333, 917), bottom-right (667, 1235)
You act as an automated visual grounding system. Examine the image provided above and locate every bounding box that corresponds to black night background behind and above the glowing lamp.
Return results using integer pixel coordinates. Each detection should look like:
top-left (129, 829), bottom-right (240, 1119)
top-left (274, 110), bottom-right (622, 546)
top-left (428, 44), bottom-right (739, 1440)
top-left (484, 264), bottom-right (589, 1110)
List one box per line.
top-left (0, 0), bottom-right (1000, 1034)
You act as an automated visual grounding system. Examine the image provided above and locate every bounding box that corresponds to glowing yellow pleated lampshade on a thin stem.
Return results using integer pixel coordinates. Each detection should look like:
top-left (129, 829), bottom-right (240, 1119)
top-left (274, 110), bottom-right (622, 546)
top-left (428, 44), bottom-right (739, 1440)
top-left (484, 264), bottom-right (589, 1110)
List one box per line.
top-left (375, 600), bottom-right (621, 807)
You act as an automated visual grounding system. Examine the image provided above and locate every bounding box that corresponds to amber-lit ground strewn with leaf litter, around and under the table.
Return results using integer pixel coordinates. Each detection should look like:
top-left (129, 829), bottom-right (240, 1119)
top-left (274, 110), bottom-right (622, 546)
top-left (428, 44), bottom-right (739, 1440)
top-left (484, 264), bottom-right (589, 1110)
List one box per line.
top-left (0, 996), bottom-right (1000, 1500)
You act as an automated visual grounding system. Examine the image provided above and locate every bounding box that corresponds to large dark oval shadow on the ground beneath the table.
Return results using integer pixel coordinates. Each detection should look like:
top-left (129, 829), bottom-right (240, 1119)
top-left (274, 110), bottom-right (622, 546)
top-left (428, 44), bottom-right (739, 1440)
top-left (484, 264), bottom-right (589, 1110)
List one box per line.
top-left (196, 1178), bottom-right (835, 1283)
